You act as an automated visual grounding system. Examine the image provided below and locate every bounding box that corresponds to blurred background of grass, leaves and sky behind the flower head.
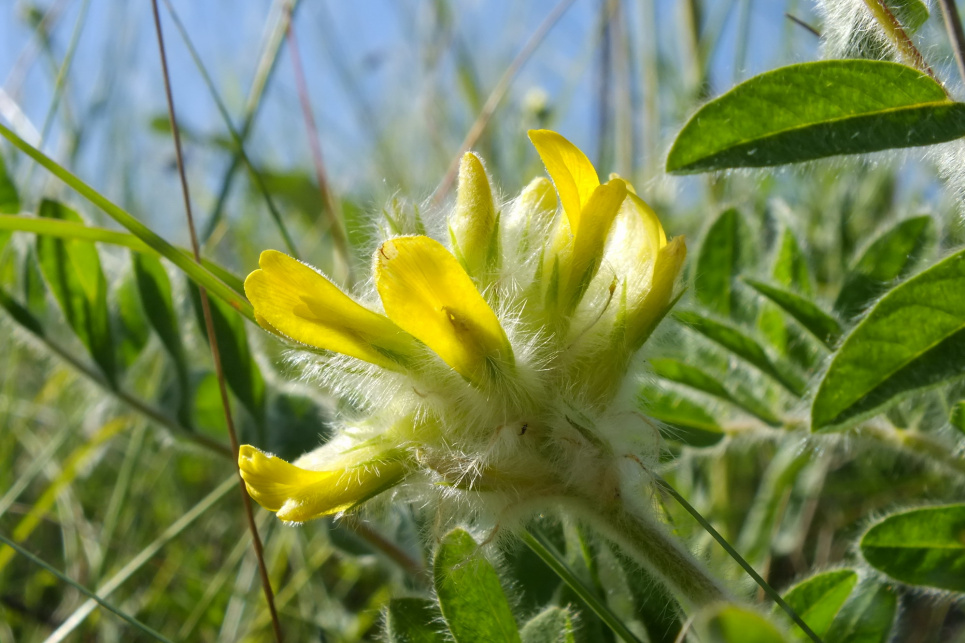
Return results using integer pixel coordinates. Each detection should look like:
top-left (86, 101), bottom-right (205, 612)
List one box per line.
top-left (0, 0), bottom-right (965, 642)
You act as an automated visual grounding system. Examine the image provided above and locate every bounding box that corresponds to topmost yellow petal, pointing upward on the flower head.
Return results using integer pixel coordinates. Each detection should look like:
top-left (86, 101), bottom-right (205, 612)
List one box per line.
top-left (529, 130), bottom-right (600, 235)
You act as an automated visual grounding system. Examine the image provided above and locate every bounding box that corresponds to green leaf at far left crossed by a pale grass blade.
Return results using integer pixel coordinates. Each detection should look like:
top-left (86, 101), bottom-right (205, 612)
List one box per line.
top-left (37, 200), bottom-right (116, 383)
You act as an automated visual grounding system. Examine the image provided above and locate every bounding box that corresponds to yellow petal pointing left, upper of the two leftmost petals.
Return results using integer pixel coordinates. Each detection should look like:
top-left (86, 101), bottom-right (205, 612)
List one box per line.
top-left (245, 250), bottom-right (417, 370)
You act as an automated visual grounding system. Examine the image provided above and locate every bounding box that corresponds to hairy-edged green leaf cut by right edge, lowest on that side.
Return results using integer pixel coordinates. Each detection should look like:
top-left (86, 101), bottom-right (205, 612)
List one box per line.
top-left (861, 504), bottom-right (965, 592)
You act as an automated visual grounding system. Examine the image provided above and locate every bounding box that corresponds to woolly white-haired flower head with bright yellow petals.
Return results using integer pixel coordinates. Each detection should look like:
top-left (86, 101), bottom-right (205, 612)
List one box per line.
top-left (239, 130), bottom-right (686, 522)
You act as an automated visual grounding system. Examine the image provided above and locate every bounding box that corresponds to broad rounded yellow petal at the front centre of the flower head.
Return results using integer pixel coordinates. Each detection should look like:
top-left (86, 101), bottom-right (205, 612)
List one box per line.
top-left (375, 237), bottom-right (513, 381)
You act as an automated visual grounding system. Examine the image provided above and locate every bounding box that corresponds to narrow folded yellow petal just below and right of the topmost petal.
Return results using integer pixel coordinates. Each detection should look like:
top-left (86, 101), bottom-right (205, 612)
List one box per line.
top-left (560, 179), bottom-right (627, 311)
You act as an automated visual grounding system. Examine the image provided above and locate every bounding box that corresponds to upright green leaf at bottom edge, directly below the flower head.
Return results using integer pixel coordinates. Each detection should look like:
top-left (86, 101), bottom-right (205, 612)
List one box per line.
top-left (432, 529), bottom-right (520, 643)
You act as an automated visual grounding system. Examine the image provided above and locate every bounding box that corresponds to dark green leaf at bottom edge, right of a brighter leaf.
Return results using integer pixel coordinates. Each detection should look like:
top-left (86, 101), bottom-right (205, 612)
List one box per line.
top-left (824, 580), bottom-right (898, 643)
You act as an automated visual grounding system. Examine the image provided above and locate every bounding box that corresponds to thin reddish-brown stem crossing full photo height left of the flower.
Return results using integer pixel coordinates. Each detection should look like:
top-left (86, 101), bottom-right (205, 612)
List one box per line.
top-left (151, 0), bottom-right (282, 643)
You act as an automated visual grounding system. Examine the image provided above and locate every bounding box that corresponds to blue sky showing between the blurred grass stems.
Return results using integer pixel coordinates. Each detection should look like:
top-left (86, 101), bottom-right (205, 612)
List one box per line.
top-left (0, 0), bottom-right (817, 240)
